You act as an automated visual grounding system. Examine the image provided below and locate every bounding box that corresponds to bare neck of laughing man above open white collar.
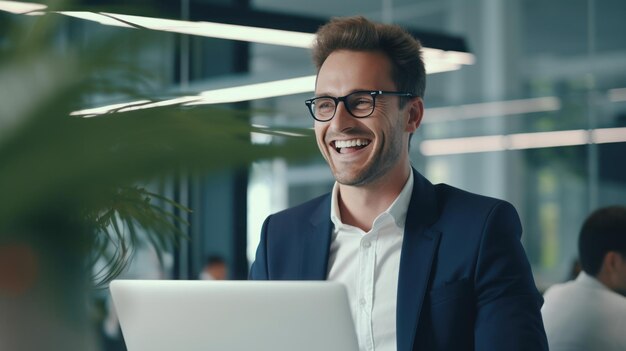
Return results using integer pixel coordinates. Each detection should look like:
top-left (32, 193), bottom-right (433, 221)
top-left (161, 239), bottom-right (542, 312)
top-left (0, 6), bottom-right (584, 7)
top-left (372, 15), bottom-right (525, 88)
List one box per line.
top-left (337, 166), bottom-right (411, 232)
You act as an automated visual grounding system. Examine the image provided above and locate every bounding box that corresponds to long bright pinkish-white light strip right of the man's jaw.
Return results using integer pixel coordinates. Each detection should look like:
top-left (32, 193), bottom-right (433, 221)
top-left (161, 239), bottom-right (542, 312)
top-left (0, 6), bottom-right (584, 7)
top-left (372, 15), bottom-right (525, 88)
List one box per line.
top-left (420, 128), bottom-right (626, 156)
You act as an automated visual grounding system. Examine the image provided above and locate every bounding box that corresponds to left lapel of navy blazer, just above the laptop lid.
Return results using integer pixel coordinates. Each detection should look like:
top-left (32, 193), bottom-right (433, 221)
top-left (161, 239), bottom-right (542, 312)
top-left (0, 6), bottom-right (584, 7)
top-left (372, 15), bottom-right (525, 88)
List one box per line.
top-left (300, 194), bottom-right (333, 280)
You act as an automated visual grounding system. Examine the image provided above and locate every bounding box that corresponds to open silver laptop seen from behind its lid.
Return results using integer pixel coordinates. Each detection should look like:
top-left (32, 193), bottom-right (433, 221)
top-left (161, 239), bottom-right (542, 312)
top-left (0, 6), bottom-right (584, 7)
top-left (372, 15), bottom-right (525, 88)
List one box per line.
top-left (110, 280), bottom-right (358, 351)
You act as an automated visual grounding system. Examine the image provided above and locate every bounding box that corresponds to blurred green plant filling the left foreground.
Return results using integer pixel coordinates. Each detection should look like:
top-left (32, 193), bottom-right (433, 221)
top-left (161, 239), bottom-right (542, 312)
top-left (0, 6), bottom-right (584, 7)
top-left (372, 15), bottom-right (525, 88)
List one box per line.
top-left (0, 7), bottom-right (315, 349)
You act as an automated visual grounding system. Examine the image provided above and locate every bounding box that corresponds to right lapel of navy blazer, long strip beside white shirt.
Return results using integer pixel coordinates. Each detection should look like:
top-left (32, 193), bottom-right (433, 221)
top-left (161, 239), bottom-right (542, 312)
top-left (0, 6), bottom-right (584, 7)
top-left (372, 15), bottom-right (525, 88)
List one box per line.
top-left (396, 170), bottom-right (441, 351)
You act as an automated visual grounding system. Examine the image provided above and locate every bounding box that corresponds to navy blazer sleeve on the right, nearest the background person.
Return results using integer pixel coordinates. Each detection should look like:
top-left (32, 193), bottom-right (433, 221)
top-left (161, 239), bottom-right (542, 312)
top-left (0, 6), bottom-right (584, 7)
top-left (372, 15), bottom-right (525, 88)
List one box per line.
top-left (474, 201), bottom-right (548, 351)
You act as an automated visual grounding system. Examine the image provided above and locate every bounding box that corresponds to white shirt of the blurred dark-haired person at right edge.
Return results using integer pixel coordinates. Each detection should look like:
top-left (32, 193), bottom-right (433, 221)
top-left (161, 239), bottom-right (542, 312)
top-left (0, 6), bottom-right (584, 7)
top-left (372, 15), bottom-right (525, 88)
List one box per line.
top-left (541, 272), bottom-right (626, 351)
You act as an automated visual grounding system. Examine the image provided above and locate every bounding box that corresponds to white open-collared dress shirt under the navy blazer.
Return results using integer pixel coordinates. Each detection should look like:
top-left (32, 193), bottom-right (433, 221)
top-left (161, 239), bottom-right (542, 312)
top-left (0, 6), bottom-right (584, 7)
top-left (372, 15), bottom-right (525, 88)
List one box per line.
top-left (328, 172), bottom-right (413, 351)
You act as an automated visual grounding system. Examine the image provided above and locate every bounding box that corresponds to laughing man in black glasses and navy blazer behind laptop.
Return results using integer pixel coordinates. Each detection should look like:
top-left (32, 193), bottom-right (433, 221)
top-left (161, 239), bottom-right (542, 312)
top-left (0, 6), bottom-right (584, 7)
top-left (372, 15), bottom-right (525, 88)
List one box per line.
top-left (250, 17), bottom-right (547, 351)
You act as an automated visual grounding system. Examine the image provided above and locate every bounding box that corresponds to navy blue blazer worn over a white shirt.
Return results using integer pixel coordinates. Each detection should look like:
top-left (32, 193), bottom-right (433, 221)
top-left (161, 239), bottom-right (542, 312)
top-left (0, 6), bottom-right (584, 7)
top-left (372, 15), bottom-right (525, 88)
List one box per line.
top-left (250, 170), bottom-right (548, 351)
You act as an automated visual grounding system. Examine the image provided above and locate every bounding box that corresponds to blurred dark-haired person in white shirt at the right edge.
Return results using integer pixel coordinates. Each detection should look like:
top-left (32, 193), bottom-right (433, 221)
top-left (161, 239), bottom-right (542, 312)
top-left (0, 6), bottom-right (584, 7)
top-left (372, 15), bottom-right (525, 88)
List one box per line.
top-left (541, 206), bottom-right (626, 351)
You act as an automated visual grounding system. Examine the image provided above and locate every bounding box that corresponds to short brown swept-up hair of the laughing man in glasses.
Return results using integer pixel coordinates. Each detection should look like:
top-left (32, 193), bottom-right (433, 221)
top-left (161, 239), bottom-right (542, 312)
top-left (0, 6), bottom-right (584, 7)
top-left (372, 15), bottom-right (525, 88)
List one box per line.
top-left (313, 16), bottom-right (426, 97)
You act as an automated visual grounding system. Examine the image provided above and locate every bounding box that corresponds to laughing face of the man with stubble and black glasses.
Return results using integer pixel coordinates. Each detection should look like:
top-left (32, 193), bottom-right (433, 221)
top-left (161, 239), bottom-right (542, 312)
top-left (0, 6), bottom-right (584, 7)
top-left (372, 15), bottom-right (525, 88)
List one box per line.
top-left (315, 50), bottom-right (421, 186)
